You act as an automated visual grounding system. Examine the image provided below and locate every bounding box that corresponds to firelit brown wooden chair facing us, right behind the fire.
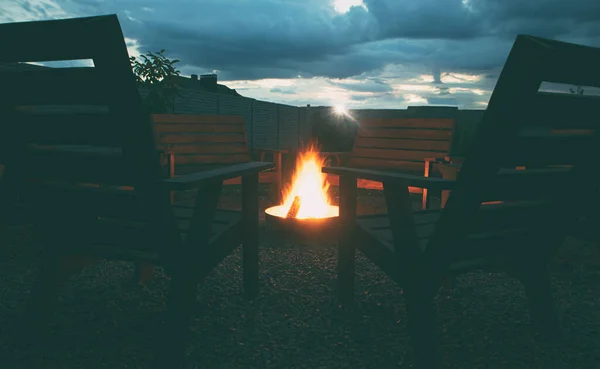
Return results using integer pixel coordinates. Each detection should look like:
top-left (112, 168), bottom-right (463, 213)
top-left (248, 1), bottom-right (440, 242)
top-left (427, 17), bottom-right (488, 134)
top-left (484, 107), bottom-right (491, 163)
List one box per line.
top-left (321, 118), bottom-right (460, 209)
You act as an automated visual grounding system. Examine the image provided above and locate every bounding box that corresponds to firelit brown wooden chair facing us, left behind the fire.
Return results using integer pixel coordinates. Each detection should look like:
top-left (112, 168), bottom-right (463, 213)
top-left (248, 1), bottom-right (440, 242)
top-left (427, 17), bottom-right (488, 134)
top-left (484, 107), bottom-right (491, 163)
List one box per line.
top-left (152, 114), bottom-right (287, 203)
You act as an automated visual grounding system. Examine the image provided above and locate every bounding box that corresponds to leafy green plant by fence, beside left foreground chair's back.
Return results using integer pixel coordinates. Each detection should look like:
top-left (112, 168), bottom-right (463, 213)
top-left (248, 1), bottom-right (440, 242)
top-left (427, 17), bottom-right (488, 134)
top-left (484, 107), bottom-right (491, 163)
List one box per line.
top-left (129, 49), bottom-right (180, 113)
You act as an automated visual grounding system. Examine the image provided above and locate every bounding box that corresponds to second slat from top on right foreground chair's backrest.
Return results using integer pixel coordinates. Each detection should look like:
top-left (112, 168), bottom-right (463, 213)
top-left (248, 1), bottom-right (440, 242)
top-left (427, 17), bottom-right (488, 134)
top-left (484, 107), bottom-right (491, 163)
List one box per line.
top-left (522, 92), bottom-right (600, 129)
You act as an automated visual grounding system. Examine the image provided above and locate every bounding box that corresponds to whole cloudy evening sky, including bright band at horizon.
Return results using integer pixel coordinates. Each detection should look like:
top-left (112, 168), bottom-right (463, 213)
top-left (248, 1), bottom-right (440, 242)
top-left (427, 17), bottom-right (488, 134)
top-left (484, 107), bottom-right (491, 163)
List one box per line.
top-left (0, 0), bottom-right (600, 109)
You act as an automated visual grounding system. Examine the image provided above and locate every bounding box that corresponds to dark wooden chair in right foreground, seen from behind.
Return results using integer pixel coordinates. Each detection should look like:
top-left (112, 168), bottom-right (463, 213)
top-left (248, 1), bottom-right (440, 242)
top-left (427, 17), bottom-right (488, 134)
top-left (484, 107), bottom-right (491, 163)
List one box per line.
top-left (323, 35), bottom-right (600, 369)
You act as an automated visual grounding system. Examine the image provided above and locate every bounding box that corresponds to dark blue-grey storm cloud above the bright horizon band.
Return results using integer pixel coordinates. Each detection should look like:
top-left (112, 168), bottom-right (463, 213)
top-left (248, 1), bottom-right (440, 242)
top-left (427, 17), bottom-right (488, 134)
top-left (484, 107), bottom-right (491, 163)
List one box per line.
top-left (4, 0), bottom-right (600, 82)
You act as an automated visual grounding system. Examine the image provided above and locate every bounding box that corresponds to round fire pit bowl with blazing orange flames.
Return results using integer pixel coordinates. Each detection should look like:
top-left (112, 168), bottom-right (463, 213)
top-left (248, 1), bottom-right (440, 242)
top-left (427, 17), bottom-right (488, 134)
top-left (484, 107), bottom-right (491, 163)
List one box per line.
top-left (265, 145), bottom-right (339, 238)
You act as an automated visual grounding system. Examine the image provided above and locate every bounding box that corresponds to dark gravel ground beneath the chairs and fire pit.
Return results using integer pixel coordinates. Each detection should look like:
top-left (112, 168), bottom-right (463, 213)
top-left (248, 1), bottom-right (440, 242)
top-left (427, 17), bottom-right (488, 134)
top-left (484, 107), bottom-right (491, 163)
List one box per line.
top-left (0, 188), bottom-right (600, 369)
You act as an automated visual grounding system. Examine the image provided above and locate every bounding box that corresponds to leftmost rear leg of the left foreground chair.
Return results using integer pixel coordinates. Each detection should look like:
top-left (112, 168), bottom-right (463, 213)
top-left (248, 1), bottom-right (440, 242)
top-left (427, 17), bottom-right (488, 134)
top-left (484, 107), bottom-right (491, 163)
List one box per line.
top-left (18, 253), bottom-right (93, 341)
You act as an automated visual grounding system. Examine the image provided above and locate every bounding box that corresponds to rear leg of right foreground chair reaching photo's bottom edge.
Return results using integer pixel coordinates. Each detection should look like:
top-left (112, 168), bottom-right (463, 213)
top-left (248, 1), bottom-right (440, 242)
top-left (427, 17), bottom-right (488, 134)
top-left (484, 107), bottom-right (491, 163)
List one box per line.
top-left (404, 285), bottom-right (440, 369)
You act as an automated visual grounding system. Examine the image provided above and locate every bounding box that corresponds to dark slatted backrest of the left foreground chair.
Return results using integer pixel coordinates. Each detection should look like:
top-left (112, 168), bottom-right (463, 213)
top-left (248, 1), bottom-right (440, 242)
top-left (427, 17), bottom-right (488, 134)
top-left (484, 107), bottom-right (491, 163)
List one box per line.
top-left (0, 15), bottom-right (163, 190)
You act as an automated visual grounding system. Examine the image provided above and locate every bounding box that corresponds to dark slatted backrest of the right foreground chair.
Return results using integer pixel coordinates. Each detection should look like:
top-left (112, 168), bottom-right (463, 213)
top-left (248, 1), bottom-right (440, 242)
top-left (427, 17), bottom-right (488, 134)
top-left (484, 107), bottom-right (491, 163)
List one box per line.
top-left (428, 36), bottom-right (600, 269)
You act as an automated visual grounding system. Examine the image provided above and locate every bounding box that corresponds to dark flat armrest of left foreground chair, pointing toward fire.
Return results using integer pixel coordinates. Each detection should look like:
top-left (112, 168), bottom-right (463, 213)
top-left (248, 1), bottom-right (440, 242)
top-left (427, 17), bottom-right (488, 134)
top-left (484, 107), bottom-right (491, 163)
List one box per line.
top-left (161, 161), bottom-right (275, 191)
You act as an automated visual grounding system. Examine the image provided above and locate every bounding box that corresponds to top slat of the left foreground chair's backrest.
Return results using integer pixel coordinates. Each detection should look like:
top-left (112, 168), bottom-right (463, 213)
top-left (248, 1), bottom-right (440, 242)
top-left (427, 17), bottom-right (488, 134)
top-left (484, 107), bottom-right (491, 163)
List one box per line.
top-left (0, 15), bottom-right (109, 62)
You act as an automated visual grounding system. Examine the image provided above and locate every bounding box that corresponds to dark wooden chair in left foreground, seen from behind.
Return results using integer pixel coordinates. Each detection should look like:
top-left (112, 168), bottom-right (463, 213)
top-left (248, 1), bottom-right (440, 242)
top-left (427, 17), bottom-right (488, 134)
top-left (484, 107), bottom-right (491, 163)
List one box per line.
top-left (0, 15), bottom-right (273, 357)
